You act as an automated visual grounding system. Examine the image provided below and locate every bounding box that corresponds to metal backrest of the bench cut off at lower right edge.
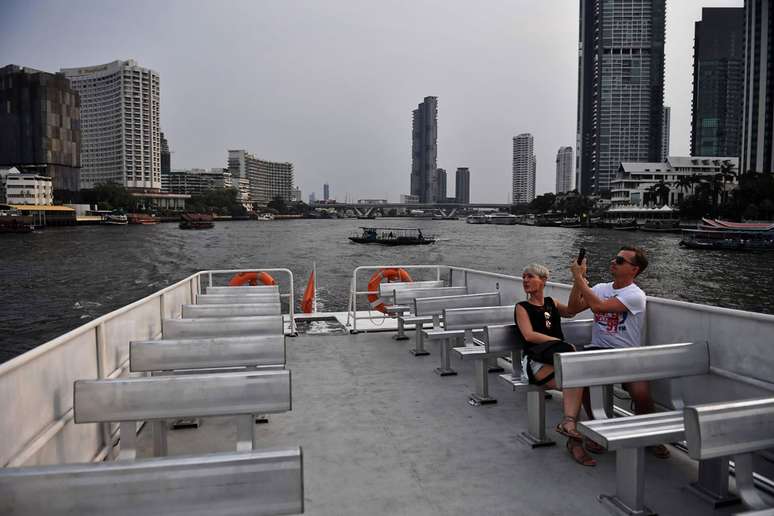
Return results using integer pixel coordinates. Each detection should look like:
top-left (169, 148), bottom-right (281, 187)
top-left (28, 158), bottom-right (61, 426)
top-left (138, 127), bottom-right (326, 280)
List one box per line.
top-left (684, 398), bottom-right (774, 460)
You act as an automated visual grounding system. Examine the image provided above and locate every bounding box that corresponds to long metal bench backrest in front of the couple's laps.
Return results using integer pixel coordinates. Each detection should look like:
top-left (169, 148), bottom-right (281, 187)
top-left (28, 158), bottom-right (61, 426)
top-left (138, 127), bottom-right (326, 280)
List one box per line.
top-left (554, 342), bottom-right (709, 388)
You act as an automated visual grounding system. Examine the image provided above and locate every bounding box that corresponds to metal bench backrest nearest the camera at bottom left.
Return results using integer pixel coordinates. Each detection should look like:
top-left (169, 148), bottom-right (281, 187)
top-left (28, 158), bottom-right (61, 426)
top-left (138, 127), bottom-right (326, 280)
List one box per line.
top-left (0, 447), bottom-right (304, 516)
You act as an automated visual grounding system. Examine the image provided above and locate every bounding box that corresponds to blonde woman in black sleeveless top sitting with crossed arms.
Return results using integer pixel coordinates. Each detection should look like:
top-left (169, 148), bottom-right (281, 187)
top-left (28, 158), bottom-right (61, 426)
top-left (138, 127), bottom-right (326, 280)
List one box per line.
top-left (514, 263), bottom-right (597, 466)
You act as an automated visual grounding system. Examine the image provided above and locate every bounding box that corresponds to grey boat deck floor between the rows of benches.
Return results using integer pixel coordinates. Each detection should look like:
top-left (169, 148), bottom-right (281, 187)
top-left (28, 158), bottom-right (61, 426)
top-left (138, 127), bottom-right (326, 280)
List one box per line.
top-left (135, 332), bottom-right (764, 516)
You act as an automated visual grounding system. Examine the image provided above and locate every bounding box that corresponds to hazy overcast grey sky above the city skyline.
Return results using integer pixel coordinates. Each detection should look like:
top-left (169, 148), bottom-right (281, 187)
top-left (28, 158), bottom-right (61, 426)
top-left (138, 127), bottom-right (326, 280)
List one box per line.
top-left (0, 0), bottom-right (743, 202)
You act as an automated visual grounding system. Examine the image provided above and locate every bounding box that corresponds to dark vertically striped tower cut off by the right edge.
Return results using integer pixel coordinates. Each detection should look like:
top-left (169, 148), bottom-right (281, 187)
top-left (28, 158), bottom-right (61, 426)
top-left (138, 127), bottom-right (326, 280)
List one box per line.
top-left (739, 0), bottom-right (774, 172)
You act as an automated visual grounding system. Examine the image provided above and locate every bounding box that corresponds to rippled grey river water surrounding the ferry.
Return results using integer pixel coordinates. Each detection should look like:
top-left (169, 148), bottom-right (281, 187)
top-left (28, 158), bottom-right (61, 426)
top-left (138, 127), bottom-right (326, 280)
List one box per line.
top-left (0, 219), bottom-right (774, 362)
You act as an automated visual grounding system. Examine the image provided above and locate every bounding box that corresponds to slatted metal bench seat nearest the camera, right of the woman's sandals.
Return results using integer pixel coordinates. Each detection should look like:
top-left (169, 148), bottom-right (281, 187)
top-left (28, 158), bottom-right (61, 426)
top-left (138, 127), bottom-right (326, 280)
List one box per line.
top-left (578, 410), bottom-right (685, 450)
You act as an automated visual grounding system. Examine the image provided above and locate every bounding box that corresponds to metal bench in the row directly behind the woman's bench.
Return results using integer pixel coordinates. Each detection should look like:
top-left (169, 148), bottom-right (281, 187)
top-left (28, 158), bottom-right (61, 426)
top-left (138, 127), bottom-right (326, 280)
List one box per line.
top-left (430, 306), bottom-right (513, 376)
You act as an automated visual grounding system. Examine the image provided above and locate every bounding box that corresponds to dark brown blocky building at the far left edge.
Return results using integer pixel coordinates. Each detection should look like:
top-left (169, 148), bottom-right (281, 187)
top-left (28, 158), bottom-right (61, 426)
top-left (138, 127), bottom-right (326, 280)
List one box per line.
top-left (0, 65), bottom-right (81, 192)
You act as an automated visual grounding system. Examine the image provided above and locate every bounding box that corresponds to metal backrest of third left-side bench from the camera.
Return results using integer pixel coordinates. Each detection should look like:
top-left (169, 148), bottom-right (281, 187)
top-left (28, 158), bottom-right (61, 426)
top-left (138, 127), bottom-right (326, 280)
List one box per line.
top-left (129, 335), bottom-right (285, 372)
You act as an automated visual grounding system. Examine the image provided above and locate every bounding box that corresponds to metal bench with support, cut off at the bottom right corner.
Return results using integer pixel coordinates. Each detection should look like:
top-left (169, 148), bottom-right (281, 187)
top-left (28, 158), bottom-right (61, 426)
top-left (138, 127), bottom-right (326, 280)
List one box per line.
top-left (683, 398), bottom-right (774, 514)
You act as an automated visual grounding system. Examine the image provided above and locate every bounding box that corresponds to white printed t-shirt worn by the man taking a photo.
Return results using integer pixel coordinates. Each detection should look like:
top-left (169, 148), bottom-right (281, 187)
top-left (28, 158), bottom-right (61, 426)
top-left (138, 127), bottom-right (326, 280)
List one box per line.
top-left (591, 282), bottom-right (645, 348)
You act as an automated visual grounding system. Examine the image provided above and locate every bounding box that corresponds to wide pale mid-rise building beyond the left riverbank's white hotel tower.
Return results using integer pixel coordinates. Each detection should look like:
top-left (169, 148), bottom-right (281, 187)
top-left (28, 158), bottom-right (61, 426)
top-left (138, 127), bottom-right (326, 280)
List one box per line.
top-left (228, 149), bottom-right (293, 206)
